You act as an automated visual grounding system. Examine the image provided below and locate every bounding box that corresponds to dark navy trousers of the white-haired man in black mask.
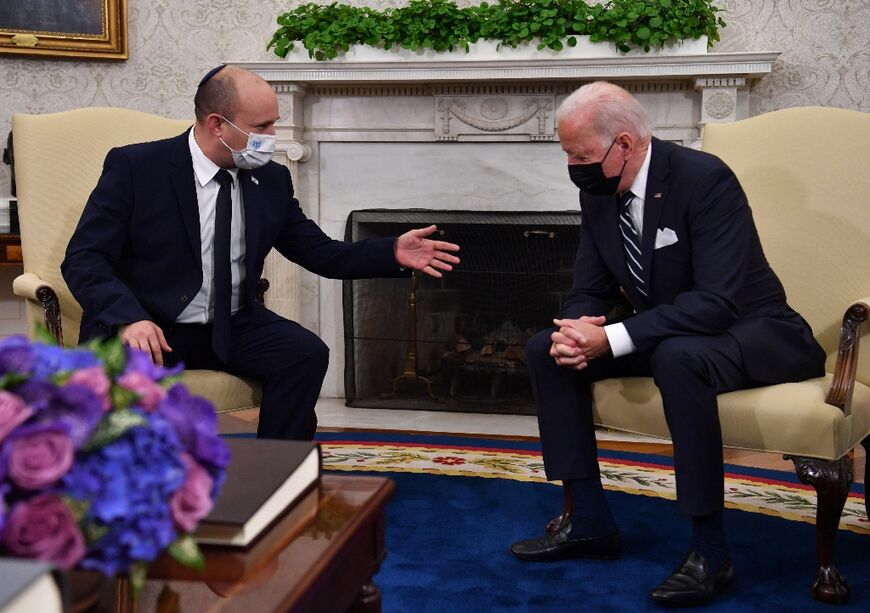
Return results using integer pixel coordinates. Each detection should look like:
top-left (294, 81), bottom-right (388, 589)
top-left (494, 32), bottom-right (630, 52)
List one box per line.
top-left (526, 330), bottom-right (756, 516)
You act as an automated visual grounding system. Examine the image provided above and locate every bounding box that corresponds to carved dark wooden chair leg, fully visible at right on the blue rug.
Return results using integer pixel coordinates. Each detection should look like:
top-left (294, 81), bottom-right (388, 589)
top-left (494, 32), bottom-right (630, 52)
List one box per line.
top-left (785, 455), bottom-right (852, 604)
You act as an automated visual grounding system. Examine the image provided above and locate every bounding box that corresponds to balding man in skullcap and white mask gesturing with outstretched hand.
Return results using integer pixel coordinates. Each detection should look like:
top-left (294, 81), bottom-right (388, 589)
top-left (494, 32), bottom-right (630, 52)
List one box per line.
top-left (61, 66), bottom-right (459, 439)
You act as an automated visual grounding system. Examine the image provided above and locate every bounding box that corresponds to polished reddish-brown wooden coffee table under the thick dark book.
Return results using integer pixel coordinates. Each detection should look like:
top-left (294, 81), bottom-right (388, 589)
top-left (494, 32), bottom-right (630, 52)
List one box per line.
top-left (107, 474), bottom-right (395, 613)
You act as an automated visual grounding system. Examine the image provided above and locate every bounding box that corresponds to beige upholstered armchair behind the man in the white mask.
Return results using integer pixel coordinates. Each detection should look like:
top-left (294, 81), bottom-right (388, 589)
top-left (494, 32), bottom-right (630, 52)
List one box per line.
top-left (12, 108), bottom-right (261, 411)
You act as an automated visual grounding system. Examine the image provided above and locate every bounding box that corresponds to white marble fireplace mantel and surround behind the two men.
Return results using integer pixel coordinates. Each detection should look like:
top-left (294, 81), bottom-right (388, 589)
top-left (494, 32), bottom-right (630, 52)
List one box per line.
top-left (235, 52), bottom-right (779, 398)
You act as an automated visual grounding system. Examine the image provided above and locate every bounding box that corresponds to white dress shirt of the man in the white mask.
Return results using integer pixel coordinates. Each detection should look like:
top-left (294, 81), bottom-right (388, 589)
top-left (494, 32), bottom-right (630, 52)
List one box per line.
top-left (176, 130), bottom-right (245, 324)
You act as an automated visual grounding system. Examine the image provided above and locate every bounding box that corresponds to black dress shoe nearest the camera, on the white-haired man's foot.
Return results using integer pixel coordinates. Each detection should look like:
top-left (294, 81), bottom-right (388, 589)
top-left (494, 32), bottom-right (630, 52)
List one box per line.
top-left (649, 551), bottom-right (736, 607)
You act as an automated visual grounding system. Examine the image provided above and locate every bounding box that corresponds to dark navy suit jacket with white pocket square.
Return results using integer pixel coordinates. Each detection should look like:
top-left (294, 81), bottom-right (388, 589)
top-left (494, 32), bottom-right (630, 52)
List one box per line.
top-left (563, 138), bottom-right (825, 383)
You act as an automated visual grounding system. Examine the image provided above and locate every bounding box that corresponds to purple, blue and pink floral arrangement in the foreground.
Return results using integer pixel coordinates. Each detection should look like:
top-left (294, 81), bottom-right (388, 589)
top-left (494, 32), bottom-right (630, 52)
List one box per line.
top-left (0, 337), bottom-right (229, 591)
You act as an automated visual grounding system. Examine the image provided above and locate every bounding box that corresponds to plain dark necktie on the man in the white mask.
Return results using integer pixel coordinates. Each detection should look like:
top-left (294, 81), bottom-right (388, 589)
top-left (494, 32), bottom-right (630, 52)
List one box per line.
top-left (211, 169), bottom-right (233, 362)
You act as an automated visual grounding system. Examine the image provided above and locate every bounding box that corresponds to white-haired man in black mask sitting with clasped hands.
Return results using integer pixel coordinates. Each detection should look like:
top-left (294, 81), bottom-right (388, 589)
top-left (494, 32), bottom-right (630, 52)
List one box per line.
top-left (511, 82), bottom-right (825, 605)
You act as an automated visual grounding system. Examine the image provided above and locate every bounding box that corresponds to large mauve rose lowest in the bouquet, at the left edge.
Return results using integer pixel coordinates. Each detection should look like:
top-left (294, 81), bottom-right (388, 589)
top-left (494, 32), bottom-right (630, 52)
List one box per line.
top-left (3, 494), bottom-right (85, 570)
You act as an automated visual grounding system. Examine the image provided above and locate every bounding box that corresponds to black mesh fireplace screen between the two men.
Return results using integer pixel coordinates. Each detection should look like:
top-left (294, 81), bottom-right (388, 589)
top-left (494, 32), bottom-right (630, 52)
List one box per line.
top-left (344, 209), bottom-right (580, 414)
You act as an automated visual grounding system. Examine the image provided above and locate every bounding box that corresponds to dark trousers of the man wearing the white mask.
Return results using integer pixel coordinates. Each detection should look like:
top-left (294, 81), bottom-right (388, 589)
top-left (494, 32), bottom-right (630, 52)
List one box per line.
top-left (161, 304), bottom-right (329, 439)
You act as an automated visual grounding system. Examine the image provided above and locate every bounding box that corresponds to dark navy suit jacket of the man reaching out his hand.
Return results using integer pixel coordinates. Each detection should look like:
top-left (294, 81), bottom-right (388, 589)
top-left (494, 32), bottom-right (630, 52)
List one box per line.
top-left (61, 132), bottom-right (400, 340)
